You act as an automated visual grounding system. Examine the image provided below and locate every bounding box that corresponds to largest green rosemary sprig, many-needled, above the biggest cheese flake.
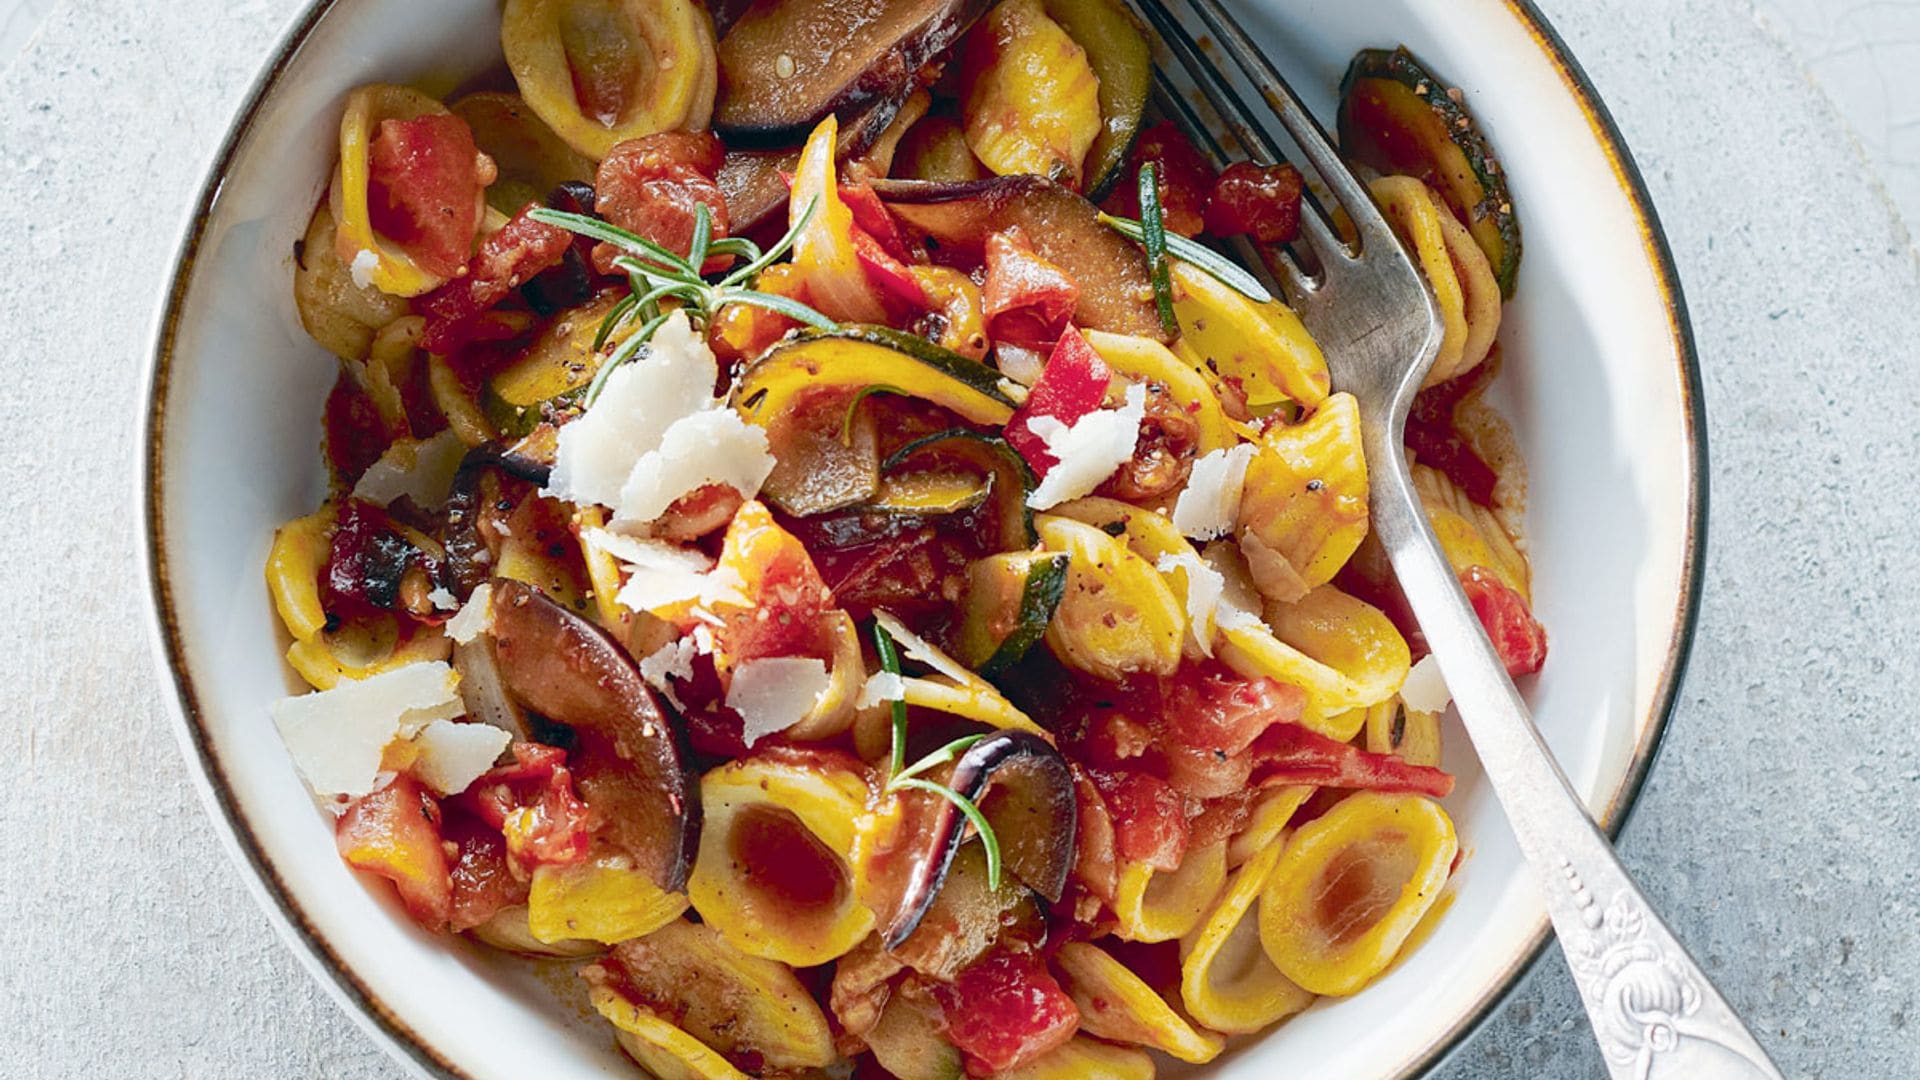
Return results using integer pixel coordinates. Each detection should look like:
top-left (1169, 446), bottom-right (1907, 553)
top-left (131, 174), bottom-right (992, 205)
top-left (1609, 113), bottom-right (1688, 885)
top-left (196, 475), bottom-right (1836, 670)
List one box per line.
top-left (528, 200), bottom-right (839, 407)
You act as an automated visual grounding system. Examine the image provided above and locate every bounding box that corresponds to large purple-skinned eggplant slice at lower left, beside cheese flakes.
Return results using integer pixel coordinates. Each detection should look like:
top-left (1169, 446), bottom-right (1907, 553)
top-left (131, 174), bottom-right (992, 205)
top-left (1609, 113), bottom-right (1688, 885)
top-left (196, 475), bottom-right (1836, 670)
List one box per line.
top-left (492, 578), bottom-right (701, 892)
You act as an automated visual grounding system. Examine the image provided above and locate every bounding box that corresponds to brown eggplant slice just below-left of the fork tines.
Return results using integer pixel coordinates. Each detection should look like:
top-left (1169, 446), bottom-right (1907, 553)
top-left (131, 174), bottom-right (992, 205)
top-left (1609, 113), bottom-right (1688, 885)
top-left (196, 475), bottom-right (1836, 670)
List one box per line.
top-left (874, 175), bottom-right (1167, 342)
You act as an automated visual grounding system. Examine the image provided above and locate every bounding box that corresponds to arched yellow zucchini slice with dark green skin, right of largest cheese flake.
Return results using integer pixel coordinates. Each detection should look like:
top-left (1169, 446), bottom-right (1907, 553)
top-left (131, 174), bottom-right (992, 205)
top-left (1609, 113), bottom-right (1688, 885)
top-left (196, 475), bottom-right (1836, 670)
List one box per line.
top-left (733, 325), bottom-right (1014, 427)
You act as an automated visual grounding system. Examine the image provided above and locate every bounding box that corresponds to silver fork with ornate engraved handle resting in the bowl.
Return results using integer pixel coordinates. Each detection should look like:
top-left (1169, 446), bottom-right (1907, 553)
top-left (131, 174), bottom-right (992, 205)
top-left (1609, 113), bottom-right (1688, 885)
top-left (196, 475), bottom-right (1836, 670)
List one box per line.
top-left (1137, 0), bottom-right (1780, 1080)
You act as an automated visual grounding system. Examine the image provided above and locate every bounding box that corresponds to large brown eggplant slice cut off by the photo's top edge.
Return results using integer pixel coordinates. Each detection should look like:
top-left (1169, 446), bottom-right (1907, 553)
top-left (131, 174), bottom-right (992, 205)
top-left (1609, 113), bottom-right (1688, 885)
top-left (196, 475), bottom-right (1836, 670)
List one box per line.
top-left (712, 0), bottom-right (991, 146)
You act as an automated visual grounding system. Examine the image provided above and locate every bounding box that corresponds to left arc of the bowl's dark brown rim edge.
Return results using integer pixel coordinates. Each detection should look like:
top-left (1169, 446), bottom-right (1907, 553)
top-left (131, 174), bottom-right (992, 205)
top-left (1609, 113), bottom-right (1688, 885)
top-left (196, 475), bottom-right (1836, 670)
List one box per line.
top-left (136, 0), bottom-right (467, 1078)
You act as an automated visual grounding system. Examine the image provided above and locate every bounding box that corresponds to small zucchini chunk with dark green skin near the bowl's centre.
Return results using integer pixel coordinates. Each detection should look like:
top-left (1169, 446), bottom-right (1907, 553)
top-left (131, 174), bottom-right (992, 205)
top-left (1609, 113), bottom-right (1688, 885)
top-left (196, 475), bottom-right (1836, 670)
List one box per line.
top-left (954, 552), bottom-right (1073, 678)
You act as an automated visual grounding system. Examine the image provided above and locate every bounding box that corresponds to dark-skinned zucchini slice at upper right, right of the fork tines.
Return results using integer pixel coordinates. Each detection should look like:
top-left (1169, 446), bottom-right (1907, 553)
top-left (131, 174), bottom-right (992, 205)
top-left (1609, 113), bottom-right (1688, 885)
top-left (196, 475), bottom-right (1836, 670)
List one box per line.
top-left (1340, 46), bottom-right (1521, 296)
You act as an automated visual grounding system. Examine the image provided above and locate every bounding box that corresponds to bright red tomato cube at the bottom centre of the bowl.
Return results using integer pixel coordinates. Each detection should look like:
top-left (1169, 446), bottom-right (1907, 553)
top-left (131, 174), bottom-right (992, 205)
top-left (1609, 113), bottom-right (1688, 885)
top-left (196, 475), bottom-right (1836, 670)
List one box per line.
top-left (933, 949), bottom-right (1079, 1076)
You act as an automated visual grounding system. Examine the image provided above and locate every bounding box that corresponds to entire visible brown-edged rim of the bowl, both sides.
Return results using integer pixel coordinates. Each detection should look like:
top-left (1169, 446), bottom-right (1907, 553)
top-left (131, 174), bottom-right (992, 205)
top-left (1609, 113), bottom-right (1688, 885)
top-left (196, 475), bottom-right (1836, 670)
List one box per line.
top-left (134, 0), bottom-right (1709, 1078)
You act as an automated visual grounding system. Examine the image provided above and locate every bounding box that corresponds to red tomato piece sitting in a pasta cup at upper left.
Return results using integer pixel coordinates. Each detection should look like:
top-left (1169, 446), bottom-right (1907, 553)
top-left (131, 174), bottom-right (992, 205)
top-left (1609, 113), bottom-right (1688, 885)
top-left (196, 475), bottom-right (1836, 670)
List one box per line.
top-left (367, 113), bottom-right (493, 277)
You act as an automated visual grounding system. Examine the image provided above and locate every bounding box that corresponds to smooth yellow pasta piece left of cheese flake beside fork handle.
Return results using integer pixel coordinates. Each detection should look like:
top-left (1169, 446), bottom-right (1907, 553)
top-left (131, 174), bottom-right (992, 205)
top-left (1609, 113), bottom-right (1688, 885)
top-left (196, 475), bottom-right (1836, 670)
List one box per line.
top-left (1265, 584), bottom-right (1413, 718)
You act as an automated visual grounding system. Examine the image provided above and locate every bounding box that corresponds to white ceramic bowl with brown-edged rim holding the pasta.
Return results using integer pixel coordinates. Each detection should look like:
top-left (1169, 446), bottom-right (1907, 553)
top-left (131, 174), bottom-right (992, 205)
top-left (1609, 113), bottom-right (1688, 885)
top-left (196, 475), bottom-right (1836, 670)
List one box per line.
top-left (144, 0), bottom-right (1705, 1078)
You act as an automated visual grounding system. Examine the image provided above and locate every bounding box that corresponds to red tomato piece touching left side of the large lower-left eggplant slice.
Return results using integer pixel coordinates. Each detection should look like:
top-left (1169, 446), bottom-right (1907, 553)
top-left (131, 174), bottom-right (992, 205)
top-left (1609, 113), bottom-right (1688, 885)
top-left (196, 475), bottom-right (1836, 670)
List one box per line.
top-left (459, 742), bottom-right (599, 874)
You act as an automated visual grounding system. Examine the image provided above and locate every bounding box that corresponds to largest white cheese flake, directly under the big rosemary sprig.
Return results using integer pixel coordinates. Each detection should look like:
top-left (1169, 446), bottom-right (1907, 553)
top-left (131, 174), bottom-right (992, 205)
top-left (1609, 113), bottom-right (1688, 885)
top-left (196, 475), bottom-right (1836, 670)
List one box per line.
top-left (545, 313), bottom-right (774, 525)
